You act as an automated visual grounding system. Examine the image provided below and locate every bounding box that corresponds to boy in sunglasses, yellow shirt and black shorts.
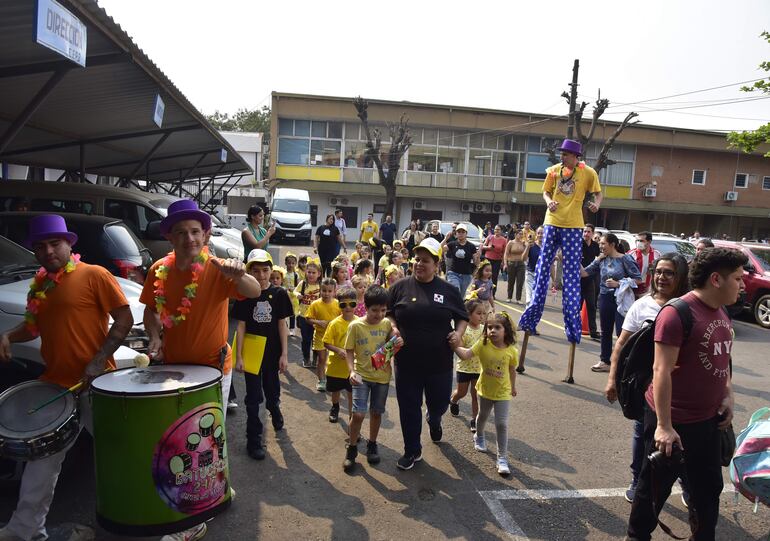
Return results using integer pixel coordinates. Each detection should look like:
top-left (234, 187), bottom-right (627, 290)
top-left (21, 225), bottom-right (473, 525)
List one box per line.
top-left (324, 287), bottom-right (357, 423)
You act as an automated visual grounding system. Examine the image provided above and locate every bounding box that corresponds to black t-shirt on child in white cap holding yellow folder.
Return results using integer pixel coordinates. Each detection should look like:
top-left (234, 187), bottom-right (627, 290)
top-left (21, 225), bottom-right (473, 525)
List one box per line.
top-left (233, 285), bottom-right (294, 363)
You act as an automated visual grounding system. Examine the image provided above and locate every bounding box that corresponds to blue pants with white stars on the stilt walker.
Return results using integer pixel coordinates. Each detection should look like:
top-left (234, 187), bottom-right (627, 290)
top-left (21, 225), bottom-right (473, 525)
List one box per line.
top-left (519, 225), bottom-right (583, 344)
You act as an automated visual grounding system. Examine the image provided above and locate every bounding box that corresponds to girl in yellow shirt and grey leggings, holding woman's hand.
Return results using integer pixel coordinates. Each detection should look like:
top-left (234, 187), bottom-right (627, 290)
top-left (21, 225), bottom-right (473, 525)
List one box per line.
top-left (452, 312), bottom-right (519, 475)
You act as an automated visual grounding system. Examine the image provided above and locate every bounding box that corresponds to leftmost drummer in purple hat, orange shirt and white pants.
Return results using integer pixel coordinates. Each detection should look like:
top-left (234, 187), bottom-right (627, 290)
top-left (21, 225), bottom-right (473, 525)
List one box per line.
top-left (0, 214), bottom-right (134, 540)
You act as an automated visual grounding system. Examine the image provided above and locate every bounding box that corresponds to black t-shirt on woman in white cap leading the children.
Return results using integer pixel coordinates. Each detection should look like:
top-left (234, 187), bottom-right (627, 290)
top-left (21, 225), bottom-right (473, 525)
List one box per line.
top-left (388, 276), bottom-right (468, 374)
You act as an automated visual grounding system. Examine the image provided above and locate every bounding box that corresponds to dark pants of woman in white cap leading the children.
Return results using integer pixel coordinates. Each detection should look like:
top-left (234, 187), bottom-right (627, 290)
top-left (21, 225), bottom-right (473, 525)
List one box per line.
top-left (396, 359), bottom-right (452, 455)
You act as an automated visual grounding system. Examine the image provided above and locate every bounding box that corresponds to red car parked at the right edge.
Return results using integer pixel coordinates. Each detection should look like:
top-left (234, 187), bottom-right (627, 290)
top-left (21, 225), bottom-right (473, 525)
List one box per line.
top-left (713, 239), bottom-right (770, 329)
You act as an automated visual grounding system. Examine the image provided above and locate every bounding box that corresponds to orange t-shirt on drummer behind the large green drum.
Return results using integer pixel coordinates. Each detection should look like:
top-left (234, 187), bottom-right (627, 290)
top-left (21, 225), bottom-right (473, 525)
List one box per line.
top-left (139, 258), bottom-right (243, 374)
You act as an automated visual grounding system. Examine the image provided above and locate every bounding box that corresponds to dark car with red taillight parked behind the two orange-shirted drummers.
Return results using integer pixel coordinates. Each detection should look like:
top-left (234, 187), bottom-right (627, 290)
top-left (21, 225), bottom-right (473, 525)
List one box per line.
top-left (0, 212), bottom-right (152, 284)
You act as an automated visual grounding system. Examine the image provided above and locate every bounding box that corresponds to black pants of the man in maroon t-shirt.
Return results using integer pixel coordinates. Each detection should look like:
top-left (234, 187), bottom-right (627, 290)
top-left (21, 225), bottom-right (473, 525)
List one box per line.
top-left (628, 406), bottom-right (723, 541)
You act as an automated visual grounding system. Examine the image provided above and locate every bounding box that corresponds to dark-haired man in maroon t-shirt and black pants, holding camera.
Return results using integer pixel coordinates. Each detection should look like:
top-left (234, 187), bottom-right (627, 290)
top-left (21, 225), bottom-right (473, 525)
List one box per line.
top-left (627, 248), bottom-right (747, 541)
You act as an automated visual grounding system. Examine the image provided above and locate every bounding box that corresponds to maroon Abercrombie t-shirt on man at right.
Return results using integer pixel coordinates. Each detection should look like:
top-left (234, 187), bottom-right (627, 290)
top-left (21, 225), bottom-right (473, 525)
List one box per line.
top-left (645, 292), bottom-right (733, 424)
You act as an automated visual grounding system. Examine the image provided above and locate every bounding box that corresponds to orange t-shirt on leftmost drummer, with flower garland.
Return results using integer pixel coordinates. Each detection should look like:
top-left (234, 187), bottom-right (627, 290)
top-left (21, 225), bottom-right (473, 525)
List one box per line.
top-left (37, 262), bottom-right (128, 387)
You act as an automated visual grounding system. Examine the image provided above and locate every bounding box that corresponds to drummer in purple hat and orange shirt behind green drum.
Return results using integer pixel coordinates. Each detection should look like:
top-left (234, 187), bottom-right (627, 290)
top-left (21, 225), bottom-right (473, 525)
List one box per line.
top-left (139, 199), bottom-right (262, 541)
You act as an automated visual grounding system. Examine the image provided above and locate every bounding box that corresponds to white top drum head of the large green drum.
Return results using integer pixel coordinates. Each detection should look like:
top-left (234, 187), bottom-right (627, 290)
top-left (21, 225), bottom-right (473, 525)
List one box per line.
top-left (91, 364), bottom-right (222, 396)
